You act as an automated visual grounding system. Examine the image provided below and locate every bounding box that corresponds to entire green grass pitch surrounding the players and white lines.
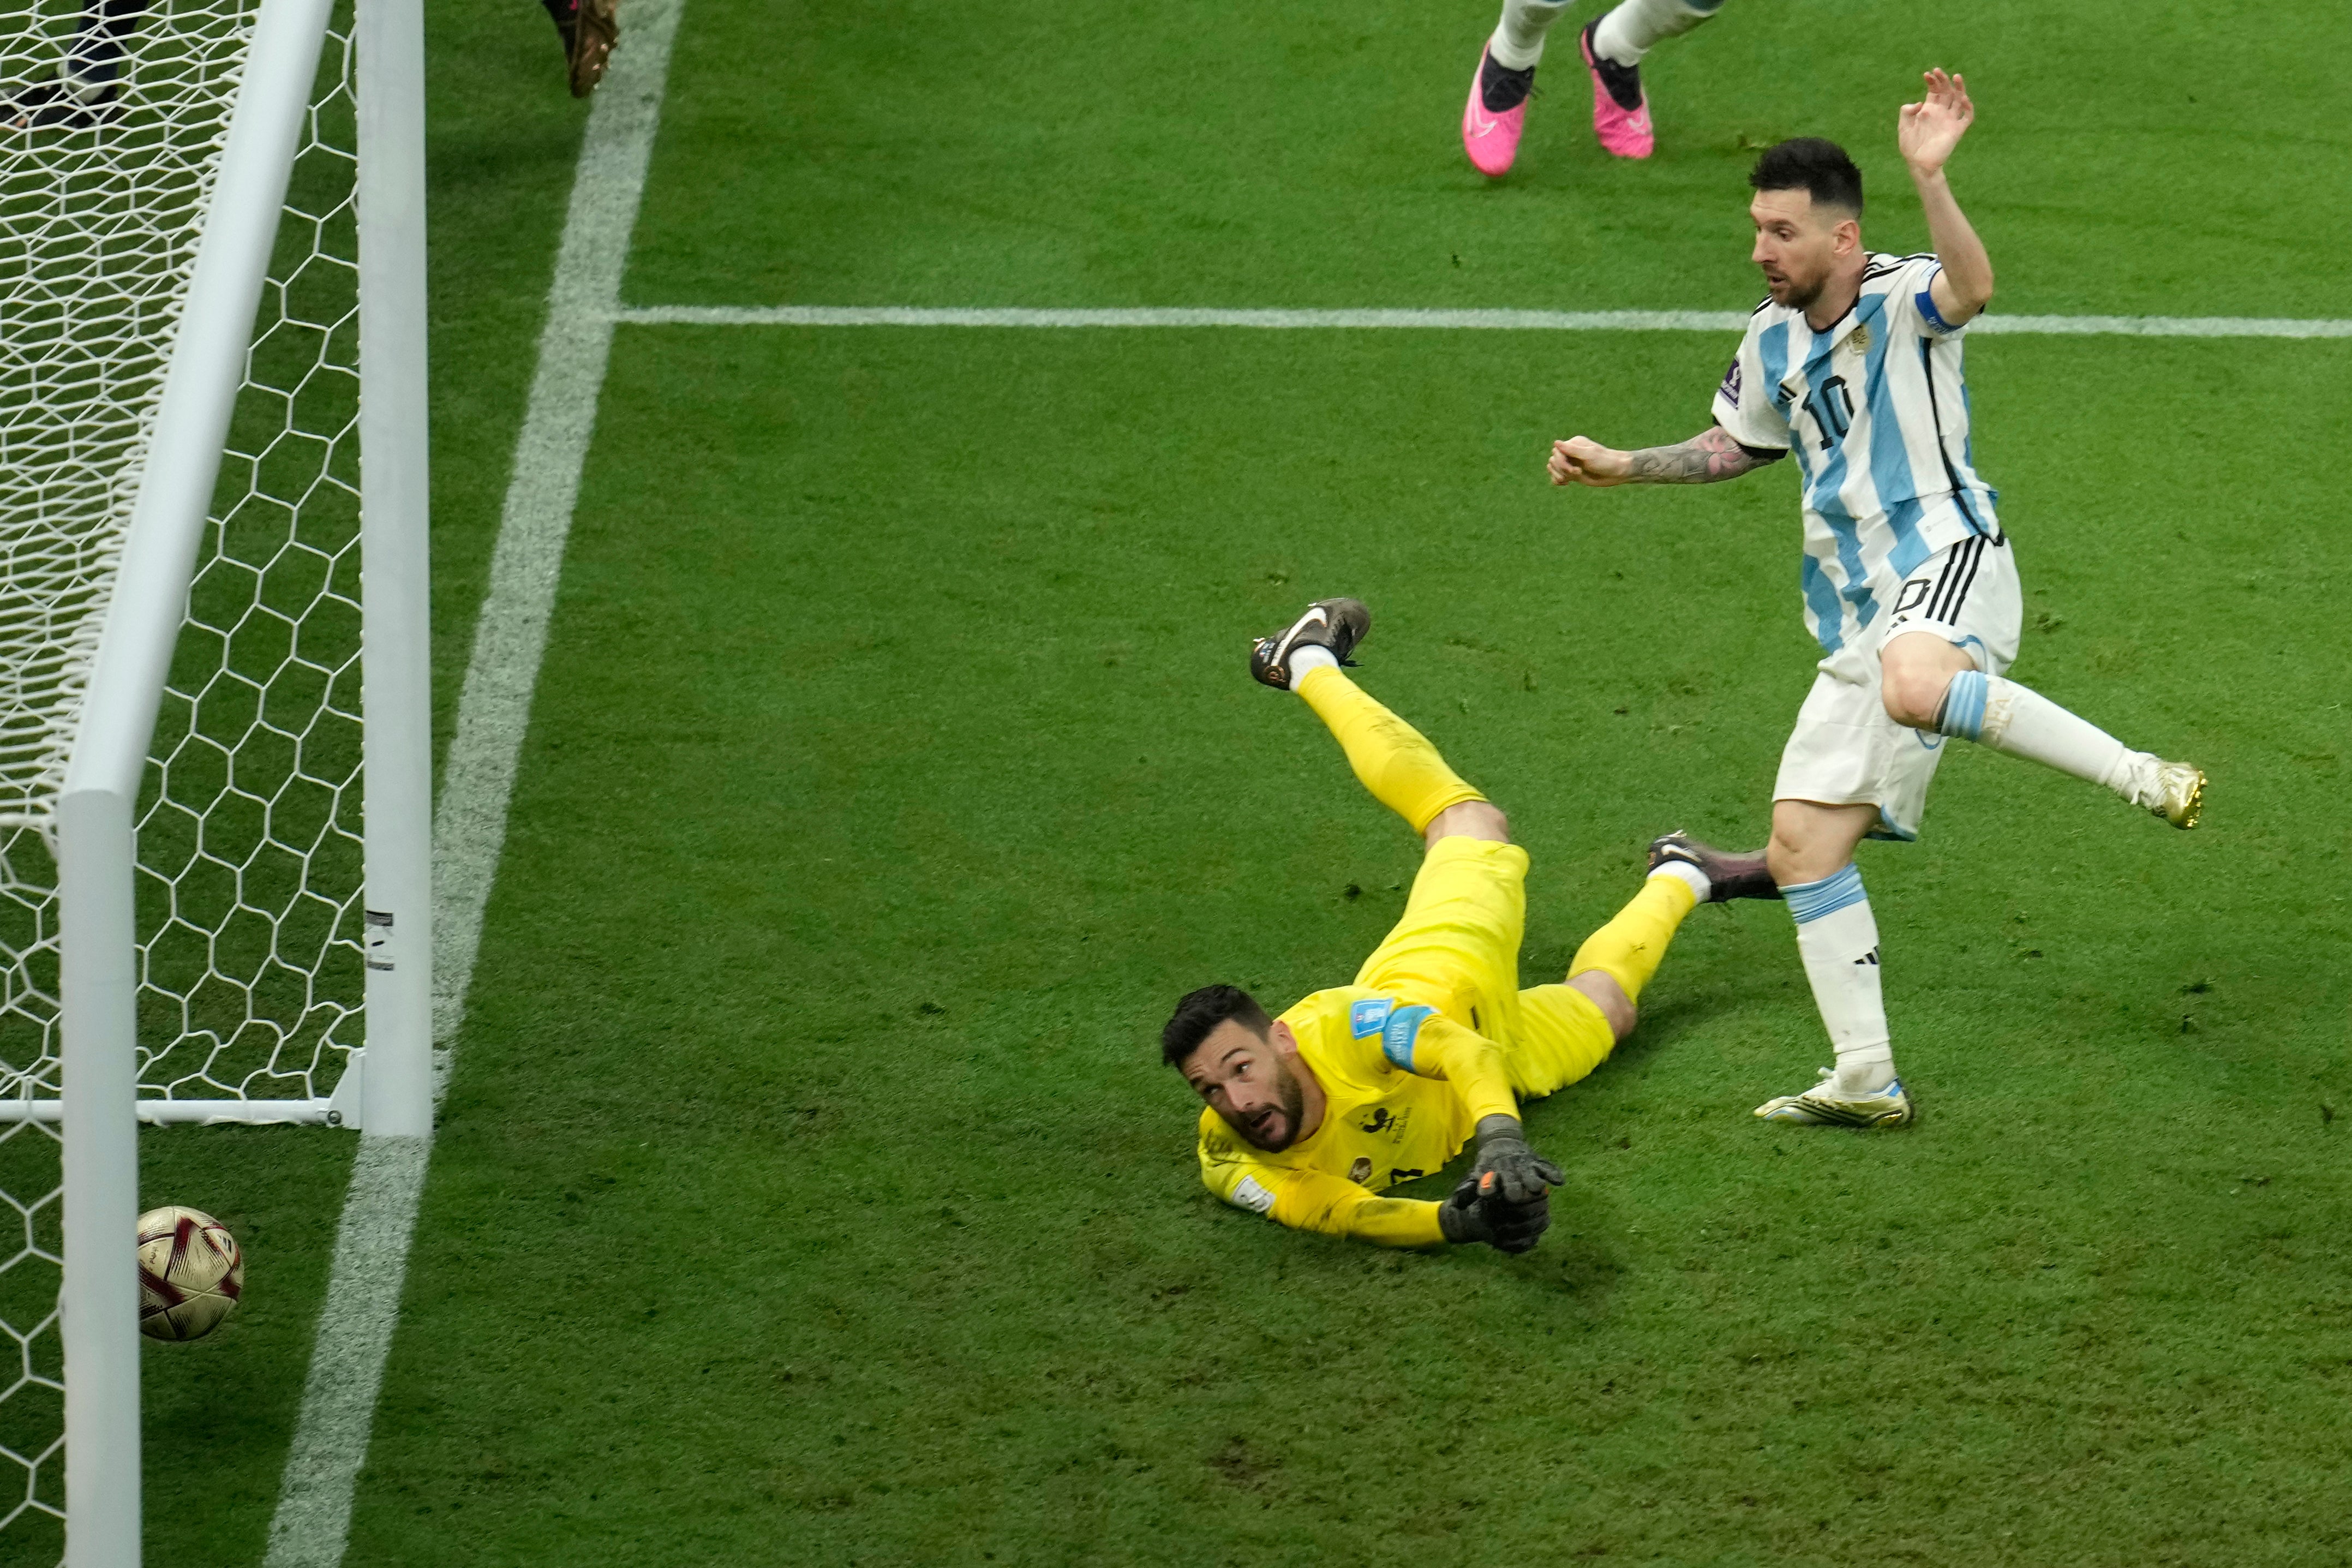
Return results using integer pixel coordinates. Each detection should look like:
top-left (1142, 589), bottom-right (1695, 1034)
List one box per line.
top-left (32, 0), bottom-right (2352, 1568)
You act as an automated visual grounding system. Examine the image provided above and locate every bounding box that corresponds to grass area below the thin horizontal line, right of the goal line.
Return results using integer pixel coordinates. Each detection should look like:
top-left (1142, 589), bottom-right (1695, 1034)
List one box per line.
top-left (353, 332), bottom-right (2352, 1568)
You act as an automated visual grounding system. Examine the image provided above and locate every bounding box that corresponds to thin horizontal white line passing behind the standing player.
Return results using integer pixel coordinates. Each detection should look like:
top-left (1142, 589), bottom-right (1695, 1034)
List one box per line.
top-left (619, 306), bottom-right (2352, 338)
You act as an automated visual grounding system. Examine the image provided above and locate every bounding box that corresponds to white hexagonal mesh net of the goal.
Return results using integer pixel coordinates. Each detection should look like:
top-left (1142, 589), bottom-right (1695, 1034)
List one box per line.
top-left (0, 0), bottom-right (364, 1561)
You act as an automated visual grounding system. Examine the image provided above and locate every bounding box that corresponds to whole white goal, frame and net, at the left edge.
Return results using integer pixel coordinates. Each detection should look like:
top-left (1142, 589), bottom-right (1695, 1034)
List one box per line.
top-left (0, 0), bottom-right (433, 1568)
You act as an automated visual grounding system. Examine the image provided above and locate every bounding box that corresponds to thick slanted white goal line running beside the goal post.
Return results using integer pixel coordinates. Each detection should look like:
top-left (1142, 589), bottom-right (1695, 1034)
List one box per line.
top-left (264, 0), bottom-right (682, 1568)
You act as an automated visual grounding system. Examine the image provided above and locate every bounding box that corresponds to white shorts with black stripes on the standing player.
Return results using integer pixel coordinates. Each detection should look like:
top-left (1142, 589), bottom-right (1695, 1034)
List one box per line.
top-left (1771, 534), bottom-right (2025, 839)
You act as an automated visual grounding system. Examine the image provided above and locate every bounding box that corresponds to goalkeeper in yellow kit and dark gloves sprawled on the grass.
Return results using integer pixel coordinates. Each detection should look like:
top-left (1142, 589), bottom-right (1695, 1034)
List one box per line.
top-left (1159, 600), bottom-right (1778, 1253)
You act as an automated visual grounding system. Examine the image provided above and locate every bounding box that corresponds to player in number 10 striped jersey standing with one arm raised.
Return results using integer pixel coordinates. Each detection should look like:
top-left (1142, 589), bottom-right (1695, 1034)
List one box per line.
top-left (1550, 70), bottom-right (2204, 1126)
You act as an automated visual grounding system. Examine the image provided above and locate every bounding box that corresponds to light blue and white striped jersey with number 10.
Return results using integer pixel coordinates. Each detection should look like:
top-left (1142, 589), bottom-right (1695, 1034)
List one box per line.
top-left (1715, 254), bottom-right (2002, 665)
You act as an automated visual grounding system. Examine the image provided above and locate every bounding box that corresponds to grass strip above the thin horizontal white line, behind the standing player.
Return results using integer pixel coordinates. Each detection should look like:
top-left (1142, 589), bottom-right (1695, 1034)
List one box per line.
top-left (630, 0), bottom-right (2352, 318)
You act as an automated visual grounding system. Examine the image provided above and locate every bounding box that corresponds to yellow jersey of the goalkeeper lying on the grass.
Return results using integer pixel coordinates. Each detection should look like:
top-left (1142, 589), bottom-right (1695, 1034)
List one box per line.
top-left (1200, 988), bottom-right (1517, 1246)
